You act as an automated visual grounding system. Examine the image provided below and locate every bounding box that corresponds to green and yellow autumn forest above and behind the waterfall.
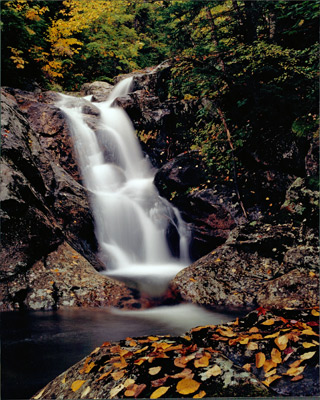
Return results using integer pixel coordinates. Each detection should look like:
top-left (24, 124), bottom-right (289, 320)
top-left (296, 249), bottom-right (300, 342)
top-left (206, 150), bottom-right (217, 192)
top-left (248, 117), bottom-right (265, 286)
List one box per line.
top-left (1, 0), bottom-right (320, 176)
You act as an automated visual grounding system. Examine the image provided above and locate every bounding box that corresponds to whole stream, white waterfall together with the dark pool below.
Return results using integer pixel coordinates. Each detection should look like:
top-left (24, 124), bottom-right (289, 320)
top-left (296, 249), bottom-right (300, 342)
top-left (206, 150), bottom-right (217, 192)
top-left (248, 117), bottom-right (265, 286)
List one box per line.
top-left (0, 78), bottom-right (235, 400)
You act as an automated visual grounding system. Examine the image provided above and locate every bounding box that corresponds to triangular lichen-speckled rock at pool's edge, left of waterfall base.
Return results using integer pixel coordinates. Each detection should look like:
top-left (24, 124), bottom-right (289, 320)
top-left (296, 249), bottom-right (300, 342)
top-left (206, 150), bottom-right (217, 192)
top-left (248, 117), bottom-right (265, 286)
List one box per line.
top-left (0, 242), bottom-right (148, 310)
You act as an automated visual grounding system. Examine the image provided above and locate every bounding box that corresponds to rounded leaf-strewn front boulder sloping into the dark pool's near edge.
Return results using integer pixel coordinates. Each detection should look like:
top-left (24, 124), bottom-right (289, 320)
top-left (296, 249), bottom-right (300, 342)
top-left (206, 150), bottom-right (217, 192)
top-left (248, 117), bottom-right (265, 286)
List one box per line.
top-left (33, 326), bottom-right (270, 399)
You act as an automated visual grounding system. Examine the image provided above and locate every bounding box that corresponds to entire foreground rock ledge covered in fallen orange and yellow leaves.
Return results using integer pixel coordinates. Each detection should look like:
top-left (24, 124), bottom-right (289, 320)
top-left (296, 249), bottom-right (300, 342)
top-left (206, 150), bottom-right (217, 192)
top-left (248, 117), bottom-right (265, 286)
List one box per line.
top-left (32, 307), bottom-right (319, 399)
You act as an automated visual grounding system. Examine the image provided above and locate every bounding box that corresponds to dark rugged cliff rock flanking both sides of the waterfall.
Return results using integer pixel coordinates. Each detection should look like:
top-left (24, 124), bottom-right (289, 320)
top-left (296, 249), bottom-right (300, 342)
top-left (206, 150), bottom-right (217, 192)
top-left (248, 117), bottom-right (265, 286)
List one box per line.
top-left (0, 63), bottom-right (319, 310)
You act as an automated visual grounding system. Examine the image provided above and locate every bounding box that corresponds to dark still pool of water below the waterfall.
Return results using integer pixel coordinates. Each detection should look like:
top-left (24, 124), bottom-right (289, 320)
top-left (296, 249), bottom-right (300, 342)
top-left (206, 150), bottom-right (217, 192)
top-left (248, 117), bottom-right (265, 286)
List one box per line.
top-left (0, 305), bottom-right (238, 400)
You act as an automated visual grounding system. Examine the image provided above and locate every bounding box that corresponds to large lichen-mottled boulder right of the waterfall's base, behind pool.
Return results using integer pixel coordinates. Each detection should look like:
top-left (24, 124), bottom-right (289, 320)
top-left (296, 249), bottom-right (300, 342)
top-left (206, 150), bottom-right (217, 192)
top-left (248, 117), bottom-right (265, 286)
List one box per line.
top-left (171, 222), bottom-right (319, 311)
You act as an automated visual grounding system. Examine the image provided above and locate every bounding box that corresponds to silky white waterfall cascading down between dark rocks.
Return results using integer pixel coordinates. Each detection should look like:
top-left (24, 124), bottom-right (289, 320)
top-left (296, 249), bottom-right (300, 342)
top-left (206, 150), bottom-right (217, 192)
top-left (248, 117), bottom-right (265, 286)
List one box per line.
top-left (58, 78), bottom-right (189, 296)
